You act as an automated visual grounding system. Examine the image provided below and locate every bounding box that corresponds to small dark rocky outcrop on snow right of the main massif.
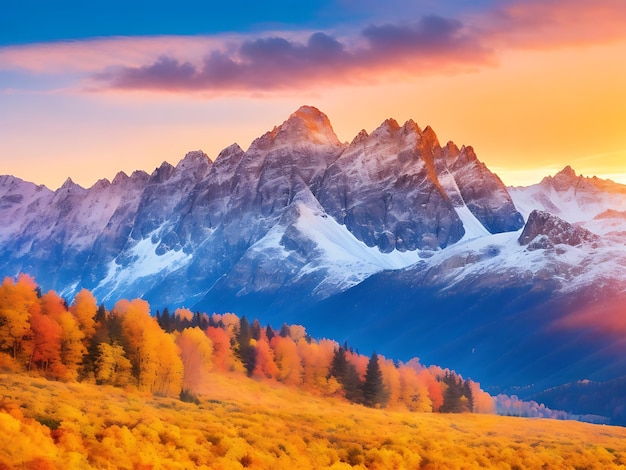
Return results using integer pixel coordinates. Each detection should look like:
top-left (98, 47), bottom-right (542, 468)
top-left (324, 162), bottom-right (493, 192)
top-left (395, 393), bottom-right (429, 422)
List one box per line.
top-left (518, 210), bottom-right (599, 250)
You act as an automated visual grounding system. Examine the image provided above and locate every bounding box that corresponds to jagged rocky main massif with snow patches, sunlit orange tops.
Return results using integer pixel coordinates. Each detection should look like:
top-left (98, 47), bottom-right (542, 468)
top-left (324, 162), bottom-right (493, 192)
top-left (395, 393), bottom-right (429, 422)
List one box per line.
top-left (0, 106), bottom-right (523, 305)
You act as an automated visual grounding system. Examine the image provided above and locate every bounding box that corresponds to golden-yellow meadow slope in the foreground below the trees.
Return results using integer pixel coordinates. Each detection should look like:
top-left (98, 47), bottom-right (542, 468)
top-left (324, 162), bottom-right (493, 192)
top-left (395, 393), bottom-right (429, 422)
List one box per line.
top-left (0, 374), bottom-right (626, 469)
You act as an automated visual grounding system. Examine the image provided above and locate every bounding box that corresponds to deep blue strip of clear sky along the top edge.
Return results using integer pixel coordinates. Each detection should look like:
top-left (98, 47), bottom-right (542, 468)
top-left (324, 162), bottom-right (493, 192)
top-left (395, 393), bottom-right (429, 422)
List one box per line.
top-left (0, 0), bottom-right (490, 45)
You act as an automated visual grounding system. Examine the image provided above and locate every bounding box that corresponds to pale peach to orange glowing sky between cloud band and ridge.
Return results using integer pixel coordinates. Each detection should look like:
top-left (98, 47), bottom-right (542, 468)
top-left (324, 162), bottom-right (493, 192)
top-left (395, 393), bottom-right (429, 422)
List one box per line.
top-left (0, 36), bottom-right (626, 189)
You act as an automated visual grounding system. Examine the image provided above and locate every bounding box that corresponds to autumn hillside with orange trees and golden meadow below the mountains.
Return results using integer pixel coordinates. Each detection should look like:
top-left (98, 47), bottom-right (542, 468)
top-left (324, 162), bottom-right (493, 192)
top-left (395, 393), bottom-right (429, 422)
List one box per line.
top-left (0, 275), bottom-right (626, 468)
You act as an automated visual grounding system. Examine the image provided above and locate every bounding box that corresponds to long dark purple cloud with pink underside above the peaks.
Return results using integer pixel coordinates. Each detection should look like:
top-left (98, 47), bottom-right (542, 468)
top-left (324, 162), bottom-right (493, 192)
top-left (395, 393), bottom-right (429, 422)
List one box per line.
top-left (95, 16), bottom-right (489, 91)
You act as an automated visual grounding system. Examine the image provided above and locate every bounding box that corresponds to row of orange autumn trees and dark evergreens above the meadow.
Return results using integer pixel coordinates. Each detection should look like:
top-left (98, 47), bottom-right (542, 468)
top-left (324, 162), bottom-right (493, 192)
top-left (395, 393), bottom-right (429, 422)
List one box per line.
top-left (0, 275), bottom-right (494, 413)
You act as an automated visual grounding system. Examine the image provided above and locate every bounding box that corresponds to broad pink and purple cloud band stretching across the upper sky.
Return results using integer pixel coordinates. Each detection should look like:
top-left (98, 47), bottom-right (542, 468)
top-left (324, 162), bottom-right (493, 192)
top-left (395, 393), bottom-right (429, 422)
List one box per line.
top-left (0, 0), bottom-right (626, 95)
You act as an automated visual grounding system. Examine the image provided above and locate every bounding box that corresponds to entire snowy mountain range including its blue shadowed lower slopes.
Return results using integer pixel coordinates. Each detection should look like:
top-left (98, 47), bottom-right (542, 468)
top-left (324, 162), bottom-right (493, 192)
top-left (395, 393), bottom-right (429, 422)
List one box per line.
top-left (0, 106), bottom-right (626, 422)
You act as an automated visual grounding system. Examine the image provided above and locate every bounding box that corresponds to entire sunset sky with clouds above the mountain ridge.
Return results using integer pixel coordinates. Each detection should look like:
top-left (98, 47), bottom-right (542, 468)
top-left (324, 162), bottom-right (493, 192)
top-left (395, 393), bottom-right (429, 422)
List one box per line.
top-left (0, 0), bottom-right (626, 189)
